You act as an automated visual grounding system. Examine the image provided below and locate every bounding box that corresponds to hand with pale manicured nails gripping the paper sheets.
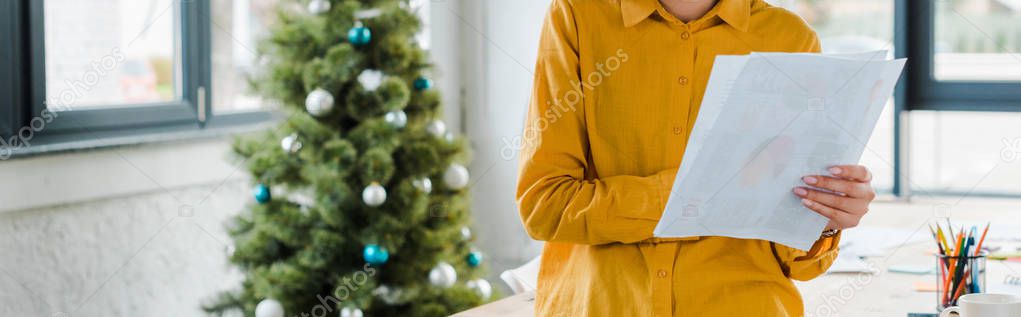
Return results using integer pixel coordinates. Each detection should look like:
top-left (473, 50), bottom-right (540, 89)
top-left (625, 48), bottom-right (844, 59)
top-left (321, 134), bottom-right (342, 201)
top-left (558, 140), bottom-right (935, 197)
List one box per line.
top-left (794, 165), bottom-right (876, 230)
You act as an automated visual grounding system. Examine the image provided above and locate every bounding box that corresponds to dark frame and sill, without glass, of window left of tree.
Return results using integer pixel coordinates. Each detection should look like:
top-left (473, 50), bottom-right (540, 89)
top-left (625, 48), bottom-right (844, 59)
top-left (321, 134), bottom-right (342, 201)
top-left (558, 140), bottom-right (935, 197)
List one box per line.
top-left (0, 0), bottom-right (279, 160)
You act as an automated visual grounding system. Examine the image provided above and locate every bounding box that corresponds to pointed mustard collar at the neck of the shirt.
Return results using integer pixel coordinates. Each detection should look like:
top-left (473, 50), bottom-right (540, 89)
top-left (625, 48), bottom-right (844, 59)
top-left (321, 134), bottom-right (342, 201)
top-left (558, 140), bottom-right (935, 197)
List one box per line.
top-left (621, 0), bottom-right (751, 32)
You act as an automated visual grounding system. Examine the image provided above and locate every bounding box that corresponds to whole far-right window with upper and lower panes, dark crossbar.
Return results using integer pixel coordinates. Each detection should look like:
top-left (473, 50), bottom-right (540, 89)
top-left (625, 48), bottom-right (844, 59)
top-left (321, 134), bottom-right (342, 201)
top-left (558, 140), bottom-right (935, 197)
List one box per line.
top-left (898, 0), bottom-right (1021, 196)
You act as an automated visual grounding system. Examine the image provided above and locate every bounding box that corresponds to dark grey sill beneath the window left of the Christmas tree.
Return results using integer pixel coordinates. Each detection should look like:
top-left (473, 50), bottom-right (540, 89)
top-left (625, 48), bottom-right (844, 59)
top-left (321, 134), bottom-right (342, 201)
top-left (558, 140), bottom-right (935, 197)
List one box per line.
top-left (0, 111), bottom-right (282, 160)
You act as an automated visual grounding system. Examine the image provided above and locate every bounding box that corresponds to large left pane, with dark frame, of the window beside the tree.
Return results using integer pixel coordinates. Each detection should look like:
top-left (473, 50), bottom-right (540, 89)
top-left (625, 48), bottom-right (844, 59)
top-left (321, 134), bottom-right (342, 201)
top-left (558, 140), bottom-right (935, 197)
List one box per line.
top-left (19, 0), bottom-right (209, 134)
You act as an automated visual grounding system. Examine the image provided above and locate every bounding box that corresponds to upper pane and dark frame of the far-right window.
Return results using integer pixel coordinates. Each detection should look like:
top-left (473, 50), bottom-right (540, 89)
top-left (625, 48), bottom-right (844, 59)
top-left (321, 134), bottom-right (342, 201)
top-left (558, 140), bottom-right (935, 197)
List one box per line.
top-left (901, 0), bottom-right (1021, 111)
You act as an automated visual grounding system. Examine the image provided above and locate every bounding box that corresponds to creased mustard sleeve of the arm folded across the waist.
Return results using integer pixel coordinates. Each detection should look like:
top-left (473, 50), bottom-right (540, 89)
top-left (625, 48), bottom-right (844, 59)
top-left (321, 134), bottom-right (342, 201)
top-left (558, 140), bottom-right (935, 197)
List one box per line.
top-left (517, 0), bottom-right (677, 244)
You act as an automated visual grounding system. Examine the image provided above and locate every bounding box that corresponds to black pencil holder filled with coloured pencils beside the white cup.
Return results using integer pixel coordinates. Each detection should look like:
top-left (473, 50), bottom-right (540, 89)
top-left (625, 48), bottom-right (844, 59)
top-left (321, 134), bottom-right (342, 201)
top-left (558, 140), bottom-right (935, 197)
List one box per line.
top-left (936, 252), bottom-right (986, 312)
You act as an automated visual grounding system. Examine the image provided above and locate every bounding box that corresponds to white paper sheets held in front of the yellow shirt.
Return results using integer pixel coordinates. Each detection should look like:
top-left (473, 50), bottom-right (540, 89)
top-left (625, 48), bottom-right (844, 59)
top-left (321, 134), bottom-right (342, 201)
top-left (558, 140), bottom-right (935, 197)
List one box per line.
top-left (654, 51), bottom-right (905, 250)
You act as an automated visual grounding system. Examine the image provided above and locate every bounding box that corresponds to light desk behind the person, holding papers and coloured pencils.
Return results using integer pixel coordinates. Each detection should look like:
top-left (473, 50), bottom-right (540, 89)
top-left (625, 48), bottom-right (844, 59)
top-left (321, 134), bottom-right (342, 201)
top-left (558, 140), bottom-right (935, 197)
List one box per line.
top-left (454, 198), bottom-right (1021, 317)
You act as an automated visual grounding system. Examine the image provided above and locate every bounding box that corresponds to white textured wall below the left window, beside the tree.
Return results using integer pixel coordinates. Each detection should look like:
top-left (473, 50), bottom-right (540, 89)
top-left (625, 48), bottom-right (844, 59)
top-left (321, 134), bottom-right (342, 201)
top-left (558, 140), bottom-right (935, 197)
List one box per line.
top-left (0, 138), bottom-right (251, 317)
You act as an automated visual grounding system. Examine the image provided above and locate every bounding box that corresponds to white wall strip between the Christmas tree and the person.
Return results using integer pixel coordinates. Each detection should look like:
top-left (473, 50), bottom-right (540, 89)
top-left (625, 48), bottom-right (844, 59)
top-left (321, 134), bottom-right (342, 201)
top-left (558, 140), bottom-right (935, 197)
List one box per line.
top-left (451, 0), bottom-right (549, 274)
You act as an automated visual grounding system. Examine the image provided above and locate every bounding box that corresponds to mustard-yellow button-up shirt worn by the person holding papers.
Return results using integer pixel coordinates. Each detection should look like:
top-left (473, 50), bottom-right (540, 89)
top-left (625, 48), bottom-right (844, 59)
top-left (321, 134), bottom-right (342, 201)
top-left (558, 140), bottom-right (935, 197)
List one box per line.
top-left (517, 0), bottom-right (839, 316)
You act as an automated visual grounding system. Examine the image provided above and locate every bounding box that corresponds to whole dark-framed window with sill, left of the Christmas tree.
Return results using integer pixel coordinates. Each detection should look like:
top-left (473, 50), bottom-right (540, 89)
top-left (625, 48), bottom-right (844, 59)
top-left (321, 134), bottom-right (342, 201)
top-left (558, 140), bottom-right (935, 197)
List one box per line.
top-left (0, 0), bottom-right (276, 160)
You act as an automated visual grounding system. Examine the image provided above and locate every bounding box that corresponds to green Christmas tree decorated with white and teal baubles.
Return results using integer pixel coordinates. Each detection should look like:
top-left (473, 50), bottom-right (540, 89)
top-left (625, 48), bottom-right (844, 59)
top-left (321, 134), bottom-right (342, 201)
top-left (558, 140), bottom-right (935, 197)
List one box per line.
top-left (204, 0), bottom-right (491, 317)
